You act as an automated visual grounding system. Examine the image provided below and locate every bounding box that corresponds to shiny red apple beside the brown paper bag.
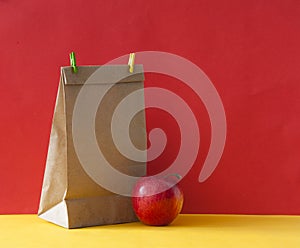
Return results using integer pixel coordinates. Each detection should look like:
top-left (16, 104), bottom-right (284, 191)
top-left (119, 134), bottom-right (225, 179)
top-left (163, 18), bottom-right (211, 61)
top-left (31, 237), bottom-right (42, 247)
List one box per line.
top-left (132, 177), bottom-right (183, 226)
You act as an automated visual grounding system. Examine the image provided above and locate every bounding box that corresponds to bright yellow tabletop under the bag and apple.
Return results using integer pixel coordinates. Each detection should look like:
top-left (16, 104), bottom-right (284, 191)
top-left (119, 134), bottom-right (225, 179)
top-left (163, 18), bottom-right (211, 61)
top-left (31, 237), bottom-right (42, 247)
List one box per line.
top-left (0, 214), bottom-right (300, 248)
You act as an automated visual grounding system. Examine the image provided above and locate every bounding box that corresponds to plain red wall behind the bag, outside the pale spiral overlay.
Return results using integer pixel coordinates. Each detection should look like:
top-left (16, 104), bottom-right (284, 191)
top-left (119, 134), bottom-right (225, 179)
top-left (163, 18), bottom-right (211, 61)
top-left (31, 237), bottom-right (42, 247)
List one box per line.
top-left (0, 0), bottom-right (300, 214)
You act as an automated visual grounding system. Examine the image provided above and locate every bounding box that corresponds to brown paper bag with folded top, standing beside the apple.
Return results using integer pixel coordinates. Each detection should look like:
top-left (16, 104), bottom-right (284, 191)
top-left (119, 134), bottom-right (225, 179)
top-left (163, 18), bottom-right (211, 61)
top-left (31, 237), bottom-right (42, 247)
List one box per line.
top-left (38, 65), bottom-right (146, 228)
